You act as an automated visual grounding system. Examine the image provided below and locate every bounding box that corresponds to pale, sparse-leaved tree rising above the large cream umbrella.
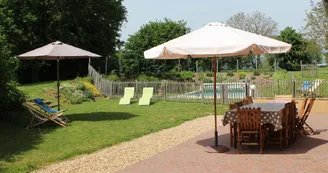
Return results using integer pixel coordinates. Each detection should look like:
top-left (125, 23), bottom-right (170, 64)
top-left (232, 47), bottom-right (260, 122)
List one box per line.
top-left (226, 11), bottom-right (278, 68)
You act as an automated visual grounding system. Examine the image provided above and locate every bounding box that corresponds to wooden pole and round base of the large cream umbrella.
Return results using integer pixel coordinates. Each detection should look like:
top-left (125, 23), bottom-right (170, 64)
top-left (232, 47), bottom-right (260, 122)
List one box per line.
top-left (207, 57), bottom-right (229, 153)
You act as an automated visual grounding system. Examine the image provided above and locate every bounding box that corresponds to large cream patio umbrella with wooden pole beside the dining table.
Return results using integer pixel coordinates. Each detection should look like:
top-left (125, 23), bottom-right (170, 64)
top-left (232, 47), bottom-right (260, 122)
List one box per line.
top-left (144, 23), bottom-right (292, 152)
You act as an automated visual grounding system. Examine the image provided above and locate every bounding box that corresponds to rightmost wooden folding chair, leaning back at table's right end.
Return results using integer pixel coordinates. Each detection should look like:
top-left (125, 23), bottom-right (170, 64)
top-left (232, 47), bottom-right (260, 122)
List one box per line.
top-left (296, 98), bottom-right (315, 136)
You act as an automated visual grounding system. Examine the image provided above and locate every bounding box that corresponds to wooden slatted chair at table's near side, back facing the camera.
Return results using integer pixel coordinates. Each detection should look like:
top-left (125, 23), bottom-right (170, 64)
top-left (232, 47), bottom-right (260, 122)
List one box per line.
top-left (237, 108), bottom-right (264, 154)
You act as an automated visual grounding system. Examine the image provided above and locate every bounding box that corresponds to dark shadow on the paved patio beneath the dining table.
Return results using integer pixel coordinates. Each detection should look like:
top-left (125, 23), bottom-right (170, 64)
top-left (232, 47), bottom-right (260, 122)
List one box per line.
top-left (196, 133), bottom-right (328, 154)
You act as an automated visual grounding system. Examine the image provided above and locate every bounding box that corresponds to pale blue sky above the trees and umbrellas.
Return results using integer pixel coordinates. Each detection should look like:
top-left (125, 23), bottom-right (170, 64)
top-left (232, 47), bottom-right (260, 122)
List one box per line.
top-left (121, 0), bottom-right (312, 41)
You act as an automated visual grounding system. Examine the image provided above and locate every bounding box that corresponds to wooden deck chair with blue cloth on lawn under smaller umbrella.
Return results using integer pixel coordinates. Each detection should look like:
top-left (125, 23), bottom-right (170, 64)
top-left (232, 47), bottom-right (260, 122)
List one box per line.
top-left (23, 98), bottom-right (68, 128)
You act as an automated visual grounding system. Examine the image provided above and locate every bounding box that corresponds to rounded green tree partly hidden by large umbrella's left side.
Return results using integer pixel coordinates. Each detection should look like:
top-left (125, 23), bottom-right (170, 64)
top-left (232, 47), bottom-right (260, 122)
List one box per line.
top-left (122, 18), bottom-right (191, 77)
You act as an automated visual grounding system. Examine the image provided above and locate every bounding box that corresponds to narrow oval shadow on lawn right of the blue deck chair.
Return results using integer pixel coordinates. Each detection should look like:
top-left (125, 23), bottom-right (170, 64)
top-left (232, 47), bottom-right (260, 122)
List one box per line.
top-left (66, 111), bottom-right (137, 121)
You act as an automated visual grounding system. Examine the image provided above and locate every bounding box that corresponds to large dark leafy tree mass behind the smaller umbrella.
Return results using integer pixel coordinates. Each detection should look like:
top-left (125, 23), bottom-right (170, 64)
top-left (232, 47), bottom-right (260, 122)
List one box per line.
top-left (0, 0), bottom-right (126, 82)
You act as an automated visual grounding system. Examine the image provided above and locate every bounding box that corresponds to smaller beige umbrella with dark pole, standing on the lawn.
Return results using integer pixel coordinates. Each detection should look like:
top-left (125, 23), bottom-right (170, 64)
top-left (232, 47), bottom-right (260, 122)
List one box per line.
top-left (18, 41), bottom-right (101, 110)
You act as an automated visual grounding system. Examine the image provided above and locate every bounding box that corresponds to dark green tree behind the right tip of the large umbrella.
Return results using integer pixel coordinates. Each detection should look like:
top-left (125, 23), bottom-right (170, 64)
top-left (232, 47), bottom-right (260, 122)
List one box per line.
top-left (270, 27), bottom-right (317, 70)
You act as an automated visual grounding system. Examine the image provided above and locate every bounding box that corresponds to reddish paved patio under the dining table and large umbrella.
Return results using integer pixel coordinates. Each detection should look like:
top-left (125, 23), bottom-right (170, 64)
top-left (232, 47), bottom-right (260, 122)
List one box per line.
top-left (119, 114), bottom-right (328, 173)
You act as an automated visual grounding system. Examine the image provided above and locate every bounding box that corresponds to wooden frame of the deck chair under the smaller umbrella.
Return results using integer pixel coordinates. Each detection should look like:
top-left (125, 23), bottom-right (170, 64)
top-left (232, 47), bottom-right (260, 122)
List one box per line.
top-left (23, 103), bottom-right (68, 128)
